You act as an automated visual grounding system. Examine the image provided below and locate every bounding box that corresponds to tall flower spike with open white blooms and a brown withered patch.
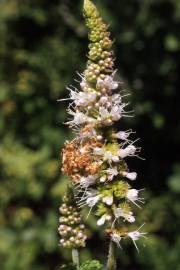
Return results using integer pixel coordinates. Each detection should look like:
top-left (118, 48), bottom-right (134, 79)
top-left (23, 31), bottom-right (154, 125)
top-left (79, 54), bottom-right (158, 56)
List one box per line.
top-left (62, 0), bottom-right (144, 251)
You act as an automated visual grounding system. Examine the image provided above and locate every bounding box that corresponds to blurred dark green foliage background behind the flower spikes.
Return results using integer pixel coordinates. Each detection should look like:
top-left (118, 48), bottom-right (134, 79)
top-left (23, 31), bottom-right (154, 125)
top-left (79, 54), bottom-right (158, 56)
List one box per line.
top-left (0, 0), bottom-right (180, 270)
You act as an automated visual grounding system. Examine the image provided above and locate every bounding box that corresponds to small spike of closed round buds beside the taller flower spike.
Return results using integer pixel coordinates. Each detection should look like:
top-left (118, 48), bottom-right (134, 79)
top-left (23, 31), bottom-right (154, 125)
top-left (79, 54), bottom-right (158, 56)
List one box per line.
top-left (58, 196), bottom-right (87, 249)
